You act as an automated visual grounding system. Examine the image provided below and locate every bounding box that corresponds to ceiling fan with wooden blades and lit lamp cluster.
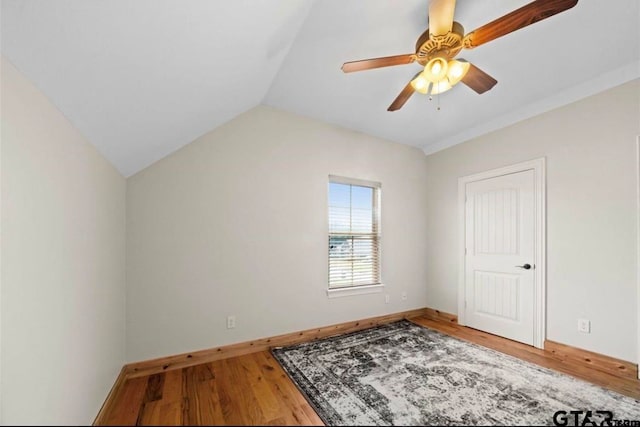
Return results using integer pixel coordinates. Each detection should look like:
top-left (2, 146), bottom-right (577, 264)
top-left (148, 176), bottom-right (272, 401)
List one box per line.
top-left (342, 0), bottom-right (578, 111)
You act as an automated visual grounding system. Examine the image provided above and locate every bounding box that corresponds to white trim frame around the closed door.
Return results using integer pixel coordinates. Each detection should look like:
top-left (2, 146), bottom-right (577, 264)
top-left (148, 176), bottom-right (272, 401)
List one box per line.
top-left (458, 157), bottom-right (548, 348)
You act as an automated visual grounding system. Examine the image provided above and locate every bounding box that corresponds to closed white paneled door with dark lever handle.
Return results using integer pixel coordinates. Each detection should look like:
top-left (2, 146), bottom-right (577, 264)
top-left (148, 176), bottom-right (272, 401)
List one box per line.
top-left (465, 170), bottom-right (536, 345)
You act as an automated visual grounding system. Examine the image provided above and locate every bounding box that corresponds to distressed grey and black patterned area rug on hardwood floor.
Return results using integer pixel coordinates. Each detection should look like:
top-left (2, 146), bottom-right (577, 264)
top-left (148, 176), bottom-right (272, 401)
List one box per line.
top-left (272, 320), bottom-right (640, 425)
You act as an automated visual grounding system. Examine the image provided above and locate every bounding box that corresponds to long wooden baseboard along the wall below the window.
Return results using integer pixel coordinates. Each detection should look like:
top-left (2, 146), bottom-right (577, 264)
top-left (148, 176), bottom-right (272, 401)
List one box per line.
top-left (124, 308), bottom-right (435, 378)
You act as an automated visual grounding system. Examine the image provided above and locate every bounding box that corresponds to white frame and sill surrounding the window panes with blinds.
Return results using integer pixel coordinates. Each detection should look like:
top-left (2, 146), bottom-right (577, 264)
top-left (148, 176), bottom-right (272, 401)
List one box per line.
top-left (326, 175), bottom-right (384, 298)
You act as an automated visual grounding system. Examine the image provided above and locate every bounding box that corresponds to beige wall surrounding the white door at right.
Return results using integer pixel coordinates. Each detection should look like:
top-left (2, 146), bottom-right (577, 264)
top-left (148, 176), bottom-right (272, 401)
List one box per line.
top-left (426, 80), bottom-right (640, 361)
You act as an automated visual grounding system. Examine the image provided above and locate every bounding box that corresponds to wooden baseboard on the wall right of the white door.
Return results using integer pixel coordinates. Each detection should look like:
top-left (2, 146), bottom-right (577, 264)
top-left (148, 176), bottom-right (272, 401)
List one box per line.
top-left (544, 340), bottom-right (638, 380)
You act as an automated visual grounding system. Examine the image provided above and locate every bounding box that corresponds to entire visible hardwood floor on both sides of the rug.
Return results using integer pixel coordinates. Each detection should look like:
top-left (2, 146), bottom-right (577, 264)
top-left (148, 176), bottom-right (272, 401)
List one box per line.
top-left (96, 316), bottom-right (640, 425)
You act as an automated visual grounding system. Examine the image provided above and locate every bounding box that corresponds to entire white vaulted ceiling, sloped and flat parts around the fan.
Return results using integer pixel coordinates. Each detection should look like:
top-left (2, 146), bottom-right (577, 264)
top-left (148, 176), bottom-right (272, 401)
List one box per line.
top-left (1, 0), bottom-right (640, 176)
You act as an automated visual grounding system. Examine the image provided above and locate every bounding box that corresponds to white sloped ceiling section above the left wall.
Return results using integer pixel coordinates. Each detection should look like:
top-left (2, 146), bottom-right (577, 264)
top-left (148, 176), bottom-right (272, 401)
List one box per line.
top-left (2, 0), bottom-right (311, 176)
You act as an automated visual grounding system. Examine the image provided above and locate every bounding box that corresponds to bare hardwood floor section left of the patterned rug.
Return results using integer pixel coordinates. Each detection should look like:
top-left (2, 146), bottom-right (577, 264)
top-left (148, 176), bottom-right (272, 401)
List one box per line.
top-left (103, 351), bottom-right (324, 426)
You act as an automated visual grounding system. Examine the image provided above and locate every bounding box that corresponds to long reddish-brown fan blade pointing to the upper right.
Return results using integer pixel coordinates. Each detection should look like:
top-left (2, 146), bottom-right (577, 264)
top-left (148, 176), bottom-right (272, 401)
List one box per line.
top-left (463, 0), bottom-right (578, 48)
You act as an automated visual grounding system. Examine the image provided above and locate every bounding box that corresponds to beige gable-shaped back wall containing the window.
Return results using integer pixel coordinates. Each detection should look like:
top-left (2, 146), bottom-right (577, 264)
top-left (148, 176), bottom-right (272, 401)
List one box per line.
top-left (127, 106), bottom-right (427, 361)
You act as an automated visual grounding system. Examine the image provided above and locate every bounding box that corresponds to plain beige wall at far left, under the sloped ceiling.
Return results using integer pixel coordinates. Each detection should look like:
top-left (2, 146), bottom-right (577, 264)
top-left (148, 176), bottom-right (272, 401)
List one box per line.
top-left (0, 58), bottom-right (126, 425)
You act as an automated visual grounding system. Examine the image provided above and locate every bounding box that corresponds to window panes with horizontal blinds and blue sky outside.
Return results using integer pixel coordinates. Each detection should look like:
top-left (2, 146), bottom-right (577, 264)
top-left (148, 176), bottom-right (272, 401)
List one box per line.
top-left (329, 176), bottom-right (380, 290)
